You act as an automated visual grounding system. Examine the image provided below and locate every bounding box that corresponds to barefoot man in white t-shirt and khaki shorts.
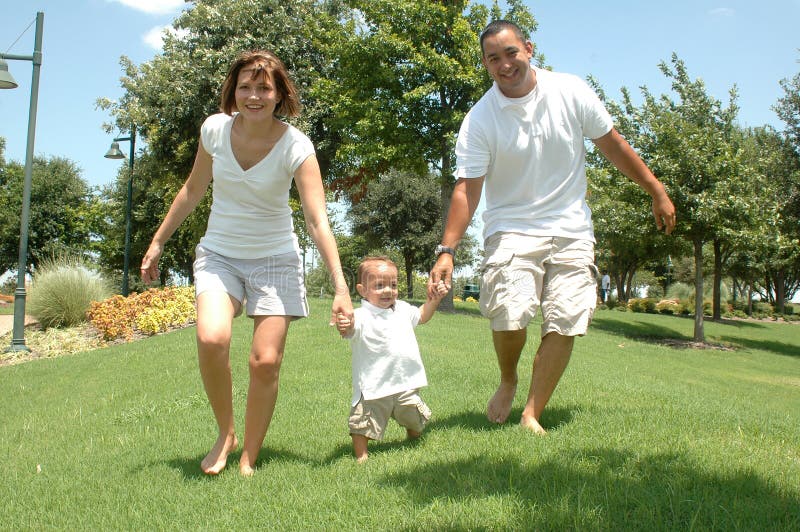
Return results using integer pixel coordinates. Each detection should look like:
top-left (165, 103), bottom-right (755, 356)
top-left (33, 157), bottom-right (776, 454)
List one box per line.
top-left (429, 20), bottom-right (675, 434)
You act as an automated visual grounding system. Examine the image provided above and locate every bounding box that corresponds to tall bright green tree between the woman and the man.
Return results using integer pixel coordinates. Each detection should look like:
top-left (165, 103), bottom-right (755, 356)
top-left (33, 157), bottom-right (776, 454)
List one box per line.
top-left (313, 0), bottom-right (536, 309)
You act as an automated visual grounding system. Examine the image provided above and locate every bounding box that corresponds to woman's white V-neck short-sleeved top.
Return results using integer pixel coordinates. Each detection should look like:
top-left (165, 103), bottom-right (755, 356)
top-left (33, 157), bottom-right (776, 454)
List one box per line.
top-left (200, 113), bottom-right (314, 259)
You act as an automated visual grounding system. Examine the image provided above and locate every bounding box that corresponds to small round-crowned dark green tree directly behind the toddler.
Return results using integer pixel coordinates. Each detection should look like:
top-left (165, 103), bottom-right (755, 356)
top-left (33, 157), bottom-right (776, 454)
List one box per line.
top-left (349, 171), bottom-right (475, 298)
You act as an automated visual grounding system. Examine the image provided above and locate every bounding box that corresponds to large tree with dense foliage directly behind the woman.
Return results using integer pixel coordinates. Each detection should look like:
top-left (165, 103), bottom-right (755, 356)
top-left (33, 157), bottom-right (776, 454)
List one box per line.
top-left (98, 0), bottom-right (342, 277)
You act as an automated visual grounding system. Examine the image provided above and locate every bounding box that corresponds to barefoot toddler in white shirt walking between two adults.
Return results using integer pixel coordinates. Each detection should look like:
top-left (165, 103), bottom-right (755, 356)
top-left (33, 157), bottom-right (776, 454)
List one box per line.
top-left (336, 257), bottom-right (447, 462)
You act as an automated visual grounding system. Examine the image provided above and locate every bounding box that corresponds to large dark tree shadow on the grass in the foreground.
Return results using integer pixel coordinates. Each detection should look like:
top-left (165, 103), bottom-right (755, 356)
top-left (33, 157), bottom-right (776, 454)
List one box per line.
top-left (380, 448), bottom-right (800, 530)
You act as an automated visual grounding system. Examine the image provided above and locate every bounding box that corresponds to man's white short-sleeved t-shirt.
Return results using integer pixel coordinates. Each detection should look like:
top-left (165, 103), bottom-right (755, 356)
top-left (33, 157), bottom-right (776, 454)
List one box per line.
top-left (454, 67), bottom-right (613, 240)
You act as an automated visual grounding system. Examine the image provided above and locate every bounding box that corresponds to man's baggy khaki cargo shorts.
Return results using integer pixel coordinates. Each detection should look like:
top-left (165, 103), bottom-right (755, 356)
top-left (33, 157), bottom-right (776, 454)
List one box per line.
top-left (480, 232), bottom-right (598, 337)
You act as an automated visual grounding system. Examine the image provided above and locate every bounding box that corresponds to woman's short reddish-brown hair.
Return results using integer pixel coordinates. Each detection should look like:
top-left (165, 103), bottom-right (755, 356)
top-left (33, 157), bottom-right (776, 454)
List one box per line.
top-left (219, 50), bottom-right (302, 117)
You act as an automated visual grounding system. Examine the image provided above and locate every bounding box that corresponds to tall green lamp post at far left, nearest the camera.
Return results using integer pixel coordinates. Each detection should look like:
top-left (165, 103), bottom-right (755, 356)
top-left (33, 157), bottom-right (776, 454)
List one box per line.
top-left (0, 11), bottom-right (44, 351)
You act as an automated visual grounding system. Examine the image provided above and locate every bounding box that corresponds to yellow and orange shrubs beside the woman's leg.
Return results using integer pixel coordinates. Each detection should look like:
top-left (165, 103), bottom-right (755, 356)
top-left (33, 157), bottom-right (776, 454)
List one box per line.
top-left (89, 286), bottom-right (197, 340)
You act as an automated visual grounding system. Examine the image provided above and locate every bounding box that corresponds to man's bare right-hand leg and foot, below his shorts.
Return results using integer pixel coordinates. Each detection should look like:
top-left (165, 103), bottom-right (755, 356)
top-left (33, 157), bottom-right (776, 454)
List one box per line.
top-left (520, 332), bottom-right (575, 434)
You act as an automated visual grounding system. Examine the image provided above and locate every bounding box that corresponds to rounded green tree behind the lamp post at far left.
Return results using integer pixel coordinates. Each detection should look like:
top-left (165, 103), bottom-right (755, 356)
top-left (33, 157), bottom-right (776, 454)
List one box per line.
top-left (0, 147), bottom-right (91, 271)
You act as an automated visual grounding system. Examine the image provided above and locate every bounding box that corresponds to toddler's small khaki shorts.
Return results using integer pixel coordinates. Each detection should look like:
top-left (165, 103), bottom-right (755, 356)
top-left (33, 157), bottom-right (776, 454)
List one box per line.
top-left (348, 390), bottom-right (431, 440)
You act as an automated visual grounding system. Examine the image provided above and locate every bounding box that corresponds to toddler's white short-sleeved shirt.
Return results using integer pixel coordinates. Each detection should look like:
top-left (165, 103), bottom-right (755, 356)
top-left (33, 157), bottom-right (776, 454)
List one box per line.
top-left (349, 300), bottom-right (428, 406)
